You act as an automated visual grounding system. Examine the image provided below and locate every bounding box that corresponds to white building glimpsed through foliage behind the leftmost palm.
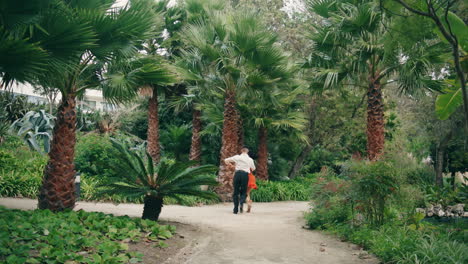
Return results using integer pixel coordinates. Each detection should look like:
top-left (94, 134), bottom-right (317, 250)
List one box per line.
top-left (9, 83), bottom-right (116, 111)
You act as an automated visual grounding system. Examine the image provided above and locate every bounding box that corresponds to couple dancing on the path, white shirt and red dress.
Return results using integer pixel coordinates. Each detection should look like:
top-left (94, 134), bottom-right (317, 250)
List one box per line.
top-left (224, 148), bottom-right (257, 214)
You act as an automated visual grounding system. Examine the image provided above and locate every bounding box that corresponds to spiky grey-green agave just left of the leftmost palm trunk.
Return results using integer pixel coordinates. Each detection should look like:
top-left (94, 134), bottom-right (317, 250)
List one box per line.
top-left (10, 110), bottom-right (55, 153)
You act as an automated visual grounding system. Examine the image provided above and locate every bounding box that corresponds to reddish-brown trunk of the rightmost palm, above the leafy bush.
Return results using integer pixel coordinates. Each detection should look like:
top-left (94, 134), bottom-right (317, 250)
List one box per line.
top-left (367, 74), bottom-right (385, 161)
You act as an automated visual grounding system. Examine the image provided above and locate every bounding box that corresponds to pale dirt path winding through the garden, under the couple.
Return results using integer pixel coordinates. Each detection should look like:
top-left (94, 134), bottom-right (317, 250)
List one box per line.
top-left (0, 198), bottom-right (378, 264)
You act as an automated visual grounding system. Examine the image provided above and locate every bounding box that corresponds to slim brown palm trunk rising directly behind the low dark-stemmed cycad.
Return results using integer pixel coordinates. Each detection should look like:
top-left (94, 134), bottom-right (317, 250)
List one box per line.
top-left (147, 87), bottom-right (161, 163)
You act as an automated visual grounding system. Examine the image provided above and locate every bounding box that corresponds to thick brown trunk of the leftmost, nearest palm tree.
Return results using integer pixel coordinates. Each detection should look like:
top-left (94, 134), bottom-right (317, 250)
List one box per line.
top-left (39, 94), bottom-right (76, 211)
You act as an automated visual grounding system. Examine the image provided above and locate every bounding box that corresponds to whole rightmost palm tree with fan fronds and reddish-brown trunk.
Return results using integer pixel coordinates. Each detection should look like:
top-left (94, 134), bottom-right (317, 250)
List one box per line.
top-left (308, 0), bottom-right (444, 160)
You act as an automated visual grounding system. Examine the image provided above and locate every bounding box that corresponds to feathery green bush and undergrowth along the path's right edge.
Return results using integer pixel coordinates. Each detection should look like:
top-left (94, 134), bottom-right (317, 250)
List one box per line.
top-left (306, 156), bottom-right (468, 263)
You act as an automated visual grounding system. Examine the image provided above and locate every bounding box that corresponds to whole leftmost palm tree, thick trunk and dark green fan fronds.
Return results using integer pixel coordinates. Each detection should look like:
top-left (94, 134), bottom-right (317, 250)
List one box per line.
top-left (1, 0), bottom-right (159, 211)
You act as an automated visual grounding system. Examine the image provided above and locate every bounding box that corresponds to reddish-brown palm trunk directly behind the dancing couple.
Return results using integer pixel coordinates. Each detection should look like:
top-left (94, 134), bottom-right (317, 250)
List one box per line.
top-left (216, 89), bottom-right (239, 201)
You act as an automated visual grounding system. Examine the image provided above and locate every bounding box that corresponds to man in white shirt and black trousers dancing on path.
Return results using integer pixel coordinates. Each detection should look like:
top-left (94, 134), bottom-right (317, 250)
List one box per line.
top-left (224, 148), bottom-right (255, 214)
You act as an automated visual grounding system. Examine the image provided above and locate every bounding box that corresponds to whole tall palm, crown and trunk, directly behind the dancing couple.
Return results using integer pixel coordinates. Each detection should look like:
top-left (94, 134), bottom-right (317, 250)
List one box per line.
top-left (179, 10), bottom-right (292, 199)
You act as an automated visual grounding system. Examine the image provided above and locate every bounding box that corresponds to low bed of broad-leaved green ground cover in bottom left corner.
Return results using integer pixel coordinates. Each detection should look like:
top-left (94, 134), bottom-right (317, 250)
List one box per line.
top-left (0, 207), bottom-right (175, 263)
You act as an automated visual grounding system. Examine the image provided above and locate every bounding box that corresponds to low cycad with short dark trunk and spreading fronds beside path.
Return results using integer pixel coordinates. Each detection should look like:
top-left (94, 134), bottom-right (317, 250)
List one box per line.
top-left (100, 140), bottom-right (218, 221)
